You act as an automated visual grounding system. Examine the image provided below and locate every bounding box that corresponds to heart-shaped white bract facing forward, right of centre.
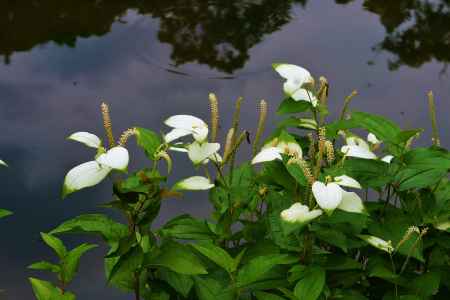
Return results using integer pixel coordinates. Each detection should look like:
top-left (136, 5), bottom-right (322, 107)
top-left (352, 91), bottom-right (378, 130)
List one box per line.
top-left (312, 181), bottom-right (343, 213)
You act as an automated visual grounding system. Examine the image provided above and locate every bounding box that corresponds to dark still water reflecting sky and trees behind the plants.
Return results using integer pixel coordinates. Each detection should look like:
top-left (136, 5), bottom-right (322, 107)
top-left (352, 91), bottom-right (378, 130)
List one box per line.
top-left (0, 0), bottom-right (450, 300)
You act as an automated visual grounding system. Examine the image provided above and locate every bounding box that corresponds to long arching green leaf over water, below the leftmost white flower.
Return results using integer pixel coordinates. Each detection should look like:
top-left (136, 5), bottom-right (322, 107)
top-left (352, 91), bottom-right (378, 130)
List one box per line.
top-left (50, 214), bottom-right (128, 244)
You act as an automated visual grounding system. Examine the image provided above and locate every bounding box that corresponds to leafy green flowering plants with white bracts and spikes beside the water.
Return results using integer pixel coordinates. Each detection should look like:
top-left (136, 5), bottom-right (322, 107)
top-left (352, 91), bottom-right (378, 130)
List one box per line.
top-left (31, 64), bottom-right (450, 300)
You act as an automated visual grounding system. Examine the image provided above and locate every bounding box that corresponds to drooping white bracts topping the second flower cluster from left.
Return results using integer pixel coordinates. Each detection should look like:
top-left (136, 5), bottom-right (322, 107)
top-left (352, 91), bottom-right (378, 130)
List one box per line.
top-left (164, 115), bottom-right (208, 143)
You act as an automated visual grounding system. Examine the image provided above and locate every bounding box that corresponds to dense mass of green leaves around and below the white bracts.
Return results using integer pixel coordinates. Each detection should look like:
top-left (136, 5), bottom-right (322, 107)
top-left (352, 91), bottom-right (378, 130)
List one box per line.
top-left (26, 64), bottom-right (450, 300)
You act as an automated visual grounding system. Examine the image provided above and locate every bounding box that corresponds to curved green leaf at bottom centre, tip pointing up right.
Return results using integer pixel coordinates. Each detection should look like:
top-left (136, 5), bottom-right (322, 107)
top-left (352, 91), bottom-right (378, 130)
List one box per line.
top-left (237, 254), bottom-right (298, 287)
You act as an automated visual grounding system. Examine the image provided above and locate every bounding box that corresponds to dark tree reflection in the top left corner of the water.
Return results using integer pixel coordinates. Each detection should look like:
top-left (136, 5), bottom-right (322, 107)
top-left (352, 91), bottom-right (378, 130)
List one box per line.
top-left (0, 0), bottom-right (135, 63)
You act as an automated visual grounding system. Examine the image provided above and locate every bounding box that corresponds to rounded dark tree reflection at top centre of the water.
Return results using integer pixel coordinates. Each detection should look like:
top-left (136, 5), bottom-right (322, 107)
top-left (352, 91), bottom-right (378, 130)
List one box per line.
top-left (136, 0), bottom-right (306, 73)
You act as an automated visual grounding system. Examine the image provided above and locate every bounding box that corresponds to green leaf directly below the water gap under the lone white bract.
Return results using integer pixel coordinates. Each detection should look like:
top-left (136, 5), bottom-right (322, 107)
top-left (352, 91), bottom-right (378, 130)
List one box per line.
top-left (159, 215), bottom-right (215, 240)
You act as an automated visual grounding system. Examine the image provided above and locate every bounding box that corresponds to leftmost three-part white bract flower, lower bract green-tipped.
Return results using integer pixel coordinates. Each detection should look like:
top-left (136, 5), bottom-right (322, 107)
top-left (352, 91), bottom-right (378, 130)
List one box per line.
top-left (63, 132), bottom-right (130, 198)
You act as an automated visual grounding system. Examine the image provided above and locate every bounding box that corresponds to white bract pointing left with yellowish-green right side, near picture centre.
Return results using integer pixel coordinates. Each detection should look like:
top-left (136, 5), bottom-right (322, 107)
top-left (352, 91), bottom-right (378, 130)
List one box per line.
top-left (252, 142), bottom-right (303, 164)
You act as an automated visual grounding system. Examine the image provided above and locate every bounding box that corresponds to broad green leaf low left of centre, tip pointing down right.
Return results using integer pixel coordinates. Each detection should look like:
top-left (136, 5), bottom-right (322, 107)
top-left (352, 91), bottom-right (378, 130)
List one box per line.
top-left (147, 242), bottom-right (208, 275)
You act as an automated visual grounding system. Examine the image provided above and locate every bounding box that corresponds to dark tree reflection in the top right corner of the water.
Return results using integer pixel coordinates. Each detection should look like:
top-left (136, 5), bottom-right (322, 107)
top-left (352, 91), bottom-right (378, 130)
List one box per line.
top-left (336, 0), bottom-right (450, 70)
